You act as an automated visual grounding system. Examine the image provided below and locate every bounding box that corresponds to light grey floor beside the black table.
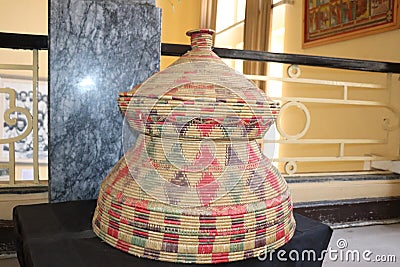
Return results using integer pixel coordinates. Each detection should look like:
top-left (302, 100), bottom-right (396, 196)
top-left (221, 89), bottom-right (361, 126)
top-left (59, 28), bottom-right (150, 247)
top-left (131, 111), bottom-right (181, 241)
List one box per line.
top-left (0, 224), bottom-right (400, 267)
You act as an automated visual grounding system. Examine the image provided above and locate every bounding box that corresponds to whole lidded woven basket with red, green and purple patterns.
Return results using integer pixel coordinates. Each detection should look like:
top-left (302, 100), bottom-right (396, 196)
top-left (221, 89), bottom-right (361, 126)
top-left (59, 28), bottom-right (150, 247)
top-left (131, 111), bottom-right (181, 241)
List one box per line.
top-left (93, 30), bottom-right (295, 263)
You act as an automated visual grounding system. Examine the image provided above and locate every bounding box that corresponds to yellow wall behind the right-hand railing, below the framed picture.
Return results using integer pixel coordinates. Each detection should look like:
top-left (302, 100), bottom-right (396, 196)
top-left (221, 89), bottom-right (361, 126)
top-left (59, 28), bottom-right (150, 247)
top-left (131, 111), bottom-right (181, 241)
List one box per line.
top-left (274, 1), bottom-right (400, 172)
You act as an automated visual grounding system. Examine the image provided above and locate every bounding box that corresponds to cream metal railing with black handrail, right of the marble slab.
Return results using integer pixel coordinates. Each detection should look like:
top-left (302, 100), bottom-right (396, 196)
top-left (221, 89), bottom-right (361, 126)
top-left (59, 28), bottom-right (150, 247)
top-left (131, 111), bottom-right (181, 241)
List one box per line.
top-left (162, 44), bottom-right (400, 175)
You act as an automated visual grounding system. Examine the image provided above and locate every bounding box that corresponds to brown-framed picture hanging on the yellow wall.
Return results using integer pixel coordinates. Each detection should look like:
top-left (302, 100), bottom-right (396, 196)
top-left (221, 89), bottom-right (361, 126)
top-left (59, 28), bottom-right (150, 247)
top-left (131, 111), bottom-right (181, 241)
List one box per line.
top-left (303, 0), bottom-right (400, 48)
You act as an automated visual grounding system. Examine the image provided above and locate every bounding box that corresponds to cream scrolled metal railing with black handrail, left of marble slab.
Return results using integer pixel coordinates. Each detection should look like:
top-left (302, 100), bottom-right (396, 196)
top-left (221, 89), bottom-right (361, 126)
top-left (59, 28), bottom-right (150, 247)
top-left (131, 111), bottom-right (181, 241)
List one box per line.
top-left (0, 33), bottom-right (47, 186)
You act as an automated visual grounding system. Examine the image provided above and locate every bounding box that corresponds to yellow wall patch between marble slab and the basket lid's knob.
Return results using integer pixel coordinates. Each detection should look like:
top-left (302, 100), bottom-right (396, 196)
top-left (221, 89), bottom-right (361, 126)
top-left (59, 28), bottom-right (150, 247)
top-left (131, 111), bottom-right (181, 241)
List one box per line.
top-left (156, 0), bottom-right (201, 69)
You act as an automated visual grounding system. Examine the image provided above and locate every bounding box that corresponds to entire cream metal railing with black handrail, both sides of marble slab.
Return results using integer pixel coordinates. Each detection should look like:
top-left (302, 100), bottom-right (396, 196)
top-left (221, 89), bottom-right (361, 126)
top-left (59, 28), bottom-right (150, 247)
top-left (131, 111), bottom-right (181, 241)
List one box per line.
top-left (0, 33), bottom-right (400, 186)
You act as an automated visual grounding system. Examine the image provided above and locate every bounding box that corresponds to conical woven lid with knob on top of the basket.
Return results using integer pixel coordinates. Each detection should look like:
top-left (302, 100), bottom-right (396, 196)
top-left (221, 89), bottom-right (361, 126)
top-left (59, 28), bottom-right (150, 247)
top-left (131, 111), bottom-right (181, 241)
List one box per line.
top-left (119, 30), bottom-right (278, 139)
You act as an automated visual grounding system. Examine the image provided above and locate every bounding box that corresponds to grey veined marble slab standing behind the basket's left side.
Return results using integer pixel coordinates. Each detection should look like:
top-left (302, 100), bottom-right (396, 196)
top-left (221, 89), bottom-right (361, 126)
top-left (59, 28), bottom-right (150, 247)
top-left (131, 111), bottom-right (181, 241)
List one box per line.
top-left (49, 0), bottom-right (161, 202)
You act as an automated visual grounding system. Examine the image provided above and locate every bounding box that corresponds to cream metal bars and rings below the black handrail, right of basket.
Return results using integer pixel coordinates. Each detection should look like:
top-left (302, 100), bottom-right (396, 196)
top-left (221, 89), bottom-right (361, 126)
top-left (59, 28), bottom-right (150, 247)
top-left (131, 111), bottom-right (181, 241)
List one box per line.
top-left (247, 68), bottom-right (400, 174)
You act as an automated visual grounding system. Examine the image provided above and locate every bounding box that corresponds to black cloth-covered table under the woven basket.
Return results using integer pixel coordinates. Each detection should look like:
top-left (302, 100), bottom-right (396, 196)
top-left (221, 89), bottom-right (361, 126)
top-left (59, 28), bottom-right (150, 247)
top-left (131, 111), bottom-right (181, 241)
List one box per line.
top-left (14, 200), bottom-right (332, 267)
